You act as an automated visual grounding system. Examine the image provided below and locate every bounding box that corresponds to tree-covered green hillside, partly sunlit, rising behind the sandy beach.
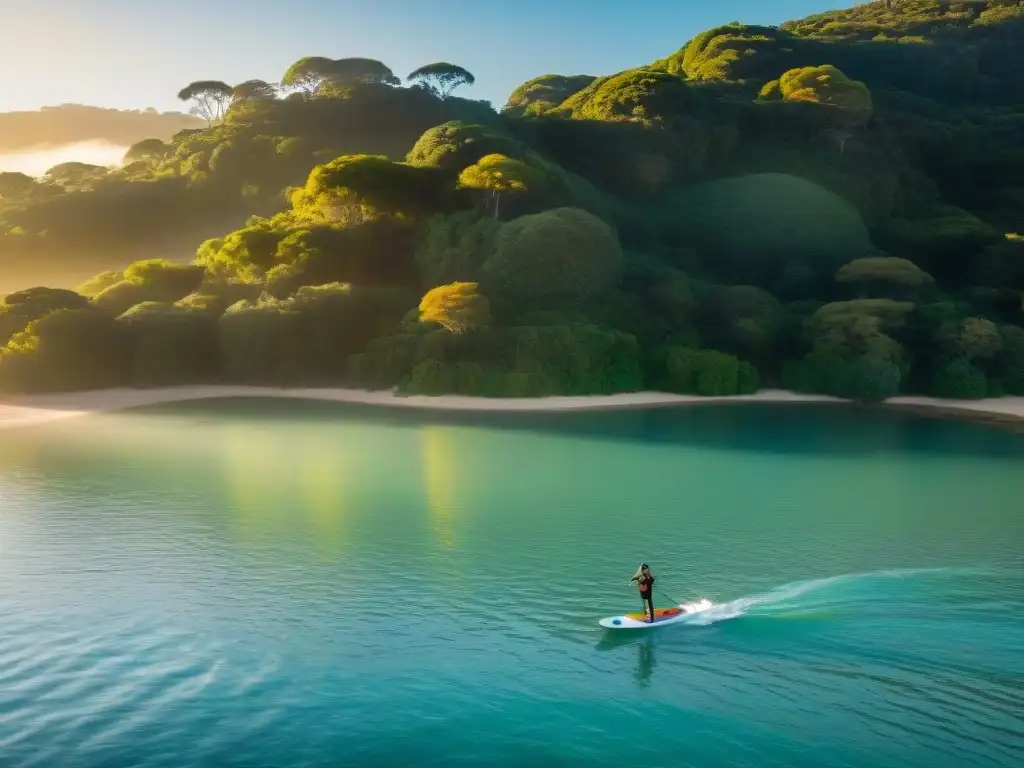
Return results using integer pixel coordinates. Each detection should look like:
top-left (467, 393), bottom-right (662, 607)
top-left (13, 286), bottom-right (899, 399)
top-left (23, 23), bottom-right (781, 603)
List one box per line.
top-left (0, 0), bottom-right (1024, 401)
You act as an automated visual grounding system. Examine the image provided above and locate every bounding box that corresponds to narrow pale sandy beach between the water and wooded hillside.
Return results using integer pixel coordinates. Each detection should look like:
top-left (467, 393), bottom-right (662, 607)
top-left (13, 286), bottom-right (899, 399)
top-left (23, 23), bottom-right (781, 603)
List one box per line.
top-left (0, 384), bottom-right (1024, 433)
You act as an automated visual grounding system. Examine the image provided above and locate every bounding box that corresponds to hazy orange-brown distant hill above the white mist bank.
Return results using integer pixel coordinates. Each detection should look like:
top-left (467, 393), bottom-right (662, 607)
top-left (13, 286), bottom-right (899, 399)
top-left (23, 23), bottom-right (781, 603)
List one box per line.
top-left (0, 104), bottom-right (205, 155)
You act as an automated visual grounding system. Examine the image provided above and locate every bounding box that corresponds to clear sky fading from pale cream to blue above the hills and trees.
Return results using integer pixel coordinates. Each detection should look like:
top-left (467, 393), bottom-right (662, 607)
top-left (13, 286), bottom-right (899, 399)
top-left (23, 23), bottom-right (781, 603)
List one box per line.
top-left (0, 0), bottom-right (852, 111)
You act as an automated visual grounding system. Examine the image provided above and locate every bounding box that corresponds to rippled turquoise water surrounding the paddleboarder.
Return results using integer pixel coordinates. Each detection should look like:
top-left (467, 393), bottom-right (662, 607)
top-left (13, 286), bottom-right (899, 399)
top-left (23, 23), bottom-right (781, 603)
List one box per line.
top-left (0, 400), bottom-right (1024, 768)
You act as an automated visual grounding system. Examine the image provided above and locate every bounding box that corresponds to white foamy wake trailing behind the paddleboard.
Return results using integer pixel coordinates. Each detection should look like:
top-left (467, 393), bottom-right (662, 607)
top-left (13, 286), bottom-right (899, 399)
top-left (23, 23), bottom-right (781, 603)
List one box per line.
top-left (685, 567), bottom-right (990, 627)
